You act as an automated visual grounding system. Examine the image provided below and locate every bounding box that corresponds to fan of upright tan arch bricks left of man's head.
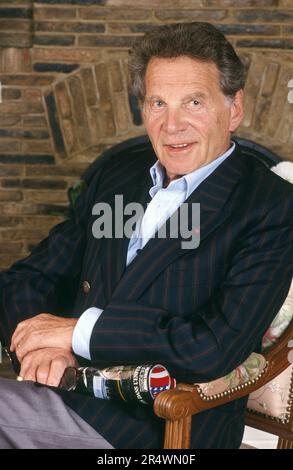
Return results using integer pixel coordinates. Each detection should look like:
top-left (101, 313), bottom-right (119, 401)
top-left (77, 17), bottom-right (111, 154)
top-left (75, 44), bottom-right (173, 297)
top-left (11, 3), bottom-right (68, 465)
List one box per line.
top-left (44, 57), bottom-right (144, 161)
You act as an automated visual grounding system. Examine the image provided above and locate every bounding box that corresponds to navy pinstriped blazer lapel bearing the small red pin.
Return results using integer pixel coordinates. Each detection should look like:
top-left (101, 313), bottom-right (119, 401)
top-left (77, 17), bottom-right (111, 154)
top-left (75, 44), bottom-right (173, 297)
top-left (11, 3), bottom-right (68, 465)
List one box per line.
top-left (112, 145), bottom-right (247, 300)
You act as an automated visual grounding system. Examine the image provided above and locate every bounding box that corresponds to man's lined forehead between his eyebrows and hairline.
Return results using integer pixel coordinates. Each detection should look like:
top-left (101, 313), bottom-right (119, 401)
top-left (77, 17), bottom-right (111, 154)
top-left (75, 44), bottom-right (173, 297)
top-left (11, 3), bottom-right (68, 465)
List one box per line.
top-left (145, 56), bottom-right (220, 94)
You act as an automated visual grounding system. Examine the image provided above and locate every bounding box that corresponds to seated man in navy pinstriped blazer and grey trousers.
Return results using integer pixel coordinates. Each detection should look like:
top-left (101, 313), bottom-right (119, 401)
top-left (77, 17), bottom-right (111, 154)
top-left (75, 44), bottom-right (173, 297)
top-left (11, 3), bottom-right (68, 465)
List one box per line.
top-left (0, 23), bottom-right (293, 448)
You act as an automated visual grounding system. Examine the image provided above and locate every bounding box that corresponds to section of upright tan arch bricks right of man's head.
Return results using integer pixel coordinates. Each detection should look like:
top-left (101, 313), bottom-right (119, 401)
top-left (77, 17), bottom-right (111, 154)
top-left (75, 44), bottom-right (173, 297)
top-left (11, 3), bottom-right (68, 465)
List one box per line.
top-left (237, 51), bottom-right (293, 160)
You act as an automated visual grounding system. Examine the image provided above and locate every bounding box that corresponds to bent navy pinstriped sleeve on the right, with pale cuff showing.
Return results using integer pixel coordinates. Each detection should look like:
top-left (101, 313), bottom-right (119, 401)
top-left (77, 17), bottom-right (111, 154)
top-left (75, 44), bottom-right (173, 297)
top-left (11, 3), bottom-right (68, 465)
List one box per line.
top-left (90, 197), bottom-right (293, 382)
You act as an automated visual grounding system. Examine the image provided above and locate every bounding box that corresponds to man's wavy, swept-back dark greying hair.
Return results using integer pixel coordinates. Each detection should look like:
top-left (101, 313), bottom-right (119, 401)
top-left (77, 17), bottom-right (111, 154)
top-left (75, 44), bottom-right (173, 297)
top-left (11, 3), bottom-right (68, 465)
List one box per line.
top-left (129, 22), bottom-right (245, 102)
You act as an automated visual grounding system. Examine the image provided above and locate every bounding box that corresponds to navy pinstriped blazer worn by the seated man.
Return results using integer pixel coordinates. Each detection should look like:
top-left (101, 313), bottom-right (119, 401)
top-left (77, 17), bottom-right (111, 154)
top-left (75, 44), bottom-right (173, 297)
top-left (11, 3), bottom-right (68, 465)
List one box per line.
top-left (0, 144), bottom-right (293, 448)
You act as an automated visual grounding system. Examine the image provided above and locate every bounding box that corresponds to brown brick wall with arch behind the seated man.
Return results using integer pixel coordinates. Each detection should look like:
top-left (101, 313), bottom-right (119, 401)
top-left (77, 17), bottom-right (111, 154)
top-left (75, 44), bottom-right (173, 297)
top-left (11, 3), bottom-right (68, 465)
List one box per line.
top-left (0, 0), bottom-right (293, 268)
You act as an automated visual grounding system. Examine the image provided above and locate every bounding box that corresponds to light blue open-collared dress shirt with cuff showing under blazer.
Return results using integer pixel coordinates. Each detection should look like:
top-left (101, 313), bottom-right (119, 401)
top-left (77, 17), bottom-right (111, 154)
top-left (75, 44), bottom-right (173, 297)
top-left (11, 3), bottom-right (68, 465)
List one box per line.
top-left (72, 142), bottom-right (235, 360)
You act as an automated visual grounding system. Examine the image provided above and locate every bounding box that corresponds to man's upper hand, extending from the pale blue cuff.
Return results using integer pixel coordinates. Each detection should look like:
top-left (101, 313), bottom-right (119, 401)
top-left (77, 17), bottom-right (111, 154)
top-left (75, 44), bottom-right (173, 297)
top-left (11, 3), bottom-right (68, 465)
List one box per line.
top-left (10, 313), bottom-right (77, 362)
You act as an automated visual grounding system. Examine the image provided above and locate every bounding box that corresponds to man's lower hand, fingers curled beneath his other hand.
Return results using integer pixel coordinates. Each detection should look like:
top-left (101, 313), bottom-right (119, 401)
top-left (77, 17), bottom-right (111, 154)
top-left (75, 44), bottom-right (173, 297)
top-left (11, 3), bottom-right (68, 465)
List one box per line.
top-left (20, 348), bottom-right (78, 387)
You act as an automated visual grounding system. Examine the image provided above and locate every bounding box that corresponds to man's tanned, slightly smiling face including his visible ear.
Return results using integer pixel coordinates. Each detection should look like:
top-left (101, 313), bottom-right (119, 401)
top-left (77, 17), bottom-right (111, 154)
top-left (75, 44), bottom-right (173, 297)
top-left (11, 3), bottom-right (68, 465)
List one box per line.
top-left (143, 56), bottom-right (243, 180)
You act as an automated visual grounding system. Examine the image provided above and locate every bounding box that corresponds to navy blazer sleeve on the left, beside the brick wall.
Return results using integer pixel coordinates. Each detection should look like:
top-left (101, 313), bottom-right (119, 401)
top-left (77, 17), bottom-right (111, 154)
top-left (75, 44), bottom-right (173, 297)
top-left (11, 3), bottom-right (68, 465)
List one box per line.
top-left (0, 159), bottom-right (104, 345)
